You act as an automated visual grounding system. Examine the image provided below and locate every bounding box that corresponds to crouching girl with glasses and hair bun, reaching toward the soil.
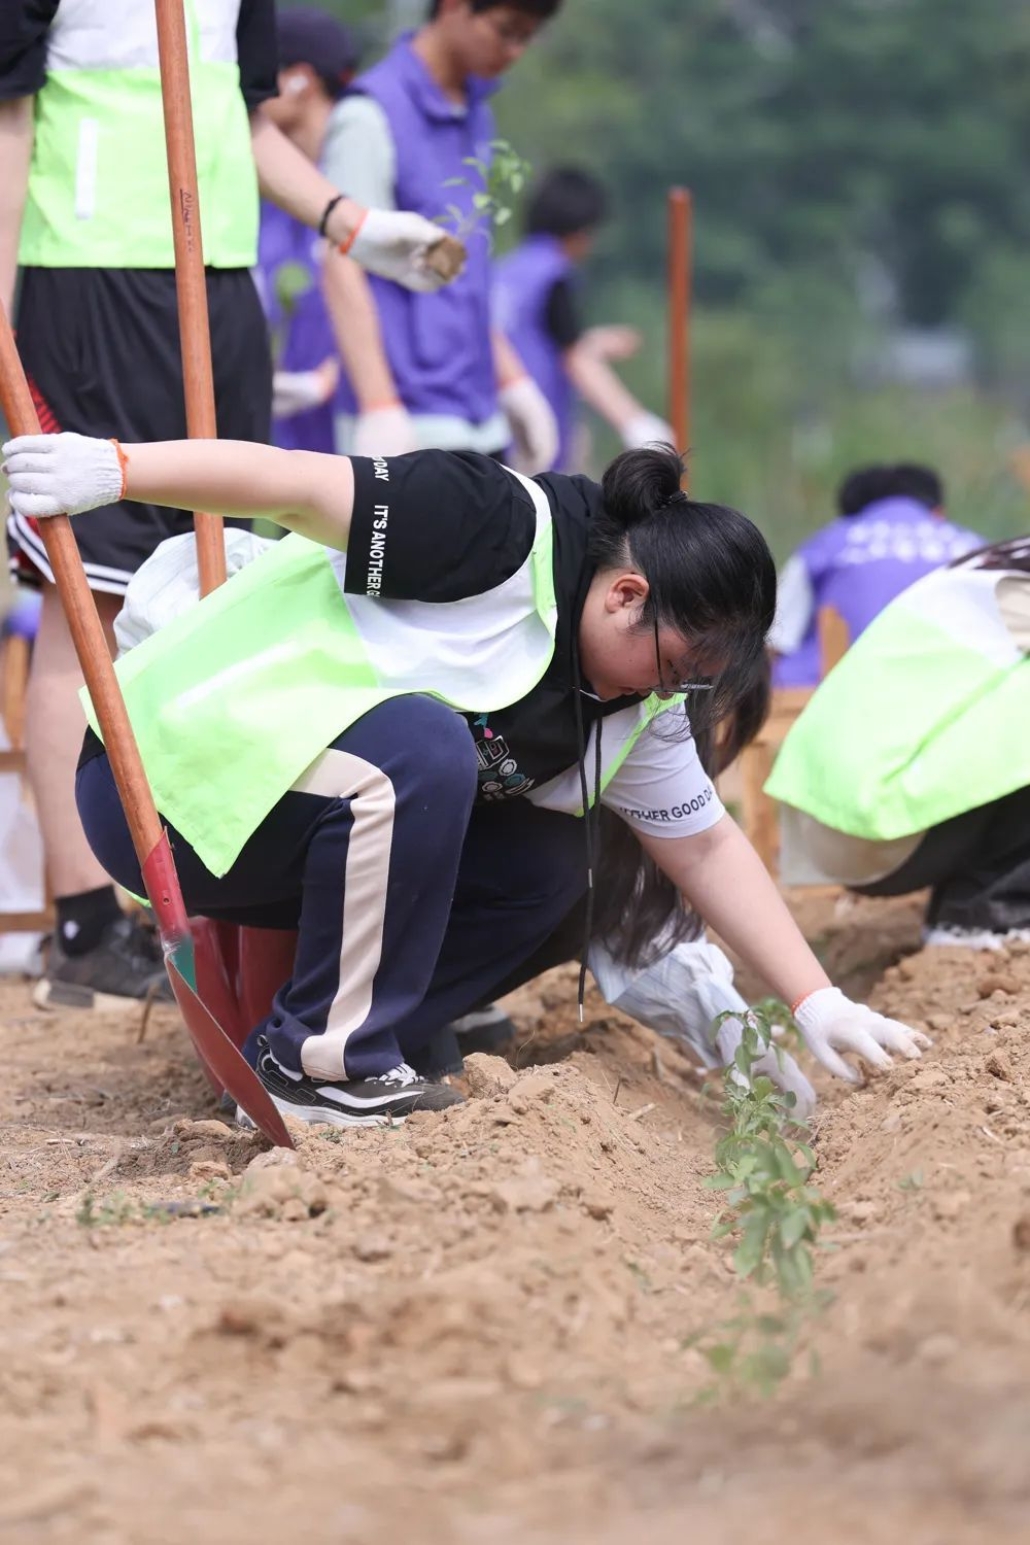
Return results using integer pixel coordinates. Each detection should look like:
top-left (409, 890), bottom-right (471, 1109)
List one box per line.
top-left (5, 434), bottom-right (927, 1126)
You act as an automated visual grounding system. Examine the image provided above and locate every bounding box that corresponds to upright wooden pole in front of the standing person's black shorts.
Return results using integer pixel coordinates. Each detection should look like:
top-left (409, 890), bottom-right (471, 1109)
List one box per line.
top-left (154, 0), bottom-right (225, 595)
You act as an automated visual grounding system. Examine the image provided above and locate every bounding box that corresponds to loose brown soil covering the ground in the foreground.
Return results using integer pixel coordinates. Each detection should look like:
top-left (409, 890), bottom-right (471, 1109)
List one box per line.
top-left (0, 896), bottom-right (1030, 1545)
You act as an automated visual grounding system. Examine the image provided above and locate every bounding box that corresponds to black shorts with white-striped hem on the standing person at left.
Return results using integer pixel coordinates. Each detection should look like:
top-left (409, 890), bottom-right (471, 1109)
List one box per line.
top-left (8, 269), bottom-right (272, 595)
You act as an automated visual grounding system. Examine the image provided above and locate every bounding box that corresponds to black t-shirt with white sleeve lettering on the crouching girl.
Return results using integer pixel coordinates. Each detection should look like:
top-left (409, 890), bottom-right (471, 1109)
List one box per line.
top-left (344, 451), bottom-right (638, 800)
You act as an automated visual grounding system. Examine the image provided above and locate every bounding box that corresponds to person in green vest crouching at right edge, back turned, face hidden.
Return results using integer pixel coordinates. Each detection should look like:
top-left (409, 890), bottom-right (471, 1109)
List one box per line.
top-left (766, 538), bottom-right (1030, 949)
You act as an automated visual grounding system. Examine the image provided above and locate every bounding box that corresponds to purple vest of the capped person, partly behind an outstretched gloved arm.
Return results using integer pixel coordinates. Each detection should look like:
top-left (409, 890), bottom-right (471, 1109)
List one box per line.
top-left (258, 204), bottom-right (337, 451)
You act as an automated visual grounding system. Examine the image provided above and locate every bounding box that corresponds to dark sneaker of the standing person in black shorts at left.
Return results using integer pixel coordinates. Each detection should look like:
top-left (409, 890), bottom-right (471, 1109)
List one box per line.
top-left (32, 918), bottom-right (173, 1014)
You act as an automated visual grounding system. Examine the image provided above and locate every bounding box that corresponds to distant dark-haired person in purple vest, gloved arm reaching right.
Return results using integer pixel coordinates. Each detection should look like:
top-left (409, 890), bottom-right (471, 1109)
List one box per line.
top-left (494, 167), bottom-right (675, 471)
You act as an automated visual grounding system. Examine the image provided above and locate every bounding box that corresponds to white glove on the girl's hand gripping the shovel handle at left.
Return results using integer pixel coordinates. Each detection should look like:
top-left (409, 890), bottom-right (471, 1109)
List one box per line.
top-left (3, 434), bottom-right (124, 516)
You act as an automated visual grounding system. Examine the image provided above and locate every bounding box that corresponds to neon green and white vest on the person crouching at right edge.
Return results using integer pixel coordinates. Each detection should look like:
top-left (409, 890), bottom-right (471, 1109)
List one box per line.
top-left (766, 565), bottom-right (1030, 842)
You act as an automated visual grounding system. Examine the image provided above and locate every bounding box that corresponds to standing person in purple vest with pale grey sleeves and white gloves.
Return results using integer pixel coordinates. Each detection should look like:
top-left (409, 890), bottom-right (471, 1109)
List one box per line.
top-left (323, 0), bottom-right (562, 471)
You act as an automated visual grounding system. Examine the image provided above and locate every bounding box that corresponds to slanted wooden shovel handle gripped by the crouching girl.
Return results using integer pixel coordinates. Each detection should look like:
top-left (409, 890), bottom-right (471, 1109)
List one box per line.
top-left (0, 306), bottom-right (162, 865)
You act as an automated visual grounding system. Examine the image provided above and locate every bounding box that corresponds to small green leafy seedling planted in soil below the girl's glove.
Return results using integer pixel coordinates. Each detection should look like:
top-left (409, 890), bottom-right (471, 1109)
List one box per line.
top-left (693, 1004), bottom-right (837, 1398)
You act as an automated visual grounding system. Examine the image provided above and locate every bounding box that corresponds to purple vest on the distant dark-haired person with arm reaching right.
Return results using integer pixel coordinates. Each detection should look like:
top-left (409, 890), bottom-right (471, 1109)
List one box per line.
top-left (494, 236), bottom-right (574, 471)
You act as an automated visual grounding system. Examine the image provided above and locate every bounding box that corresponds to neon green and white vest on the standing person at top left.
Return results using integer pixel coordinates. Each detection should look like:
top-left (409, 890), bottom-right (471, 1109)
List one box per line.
top-left (19, 0), bottom-right (258, 269)
